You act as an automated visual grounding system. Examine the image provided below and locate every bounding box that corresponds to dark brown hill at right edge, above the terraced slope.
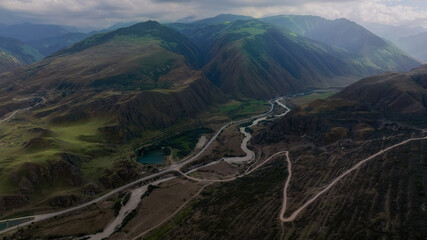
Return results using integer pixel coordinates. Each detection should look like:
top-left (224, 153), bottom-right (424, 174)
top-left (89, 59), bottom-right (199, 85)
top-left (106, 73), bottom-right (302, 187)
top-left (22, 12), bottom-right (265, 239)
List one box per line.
top-left (335, 65), bottom-right (427, 118)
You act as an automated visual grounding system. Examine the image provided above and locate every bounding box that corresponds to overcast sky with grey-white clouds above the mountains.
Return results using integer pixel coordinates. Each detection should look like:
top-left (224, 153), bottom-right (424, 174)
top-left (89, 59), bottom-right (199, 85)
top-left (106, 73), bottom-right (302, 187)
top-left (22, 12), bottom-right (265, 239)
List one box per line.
top-left (0, 0), bottom-right (427, 29)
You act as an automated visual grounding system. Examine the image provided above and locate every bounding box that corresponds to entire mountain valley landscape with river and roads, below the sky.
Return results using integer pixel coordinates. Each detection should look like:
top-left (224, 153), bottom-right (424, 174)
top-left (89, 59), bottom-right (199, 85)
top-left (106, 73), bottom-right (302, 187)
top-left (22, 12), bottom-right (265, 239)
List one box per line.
top-left (0, 11), bottom-right (427, 240)
